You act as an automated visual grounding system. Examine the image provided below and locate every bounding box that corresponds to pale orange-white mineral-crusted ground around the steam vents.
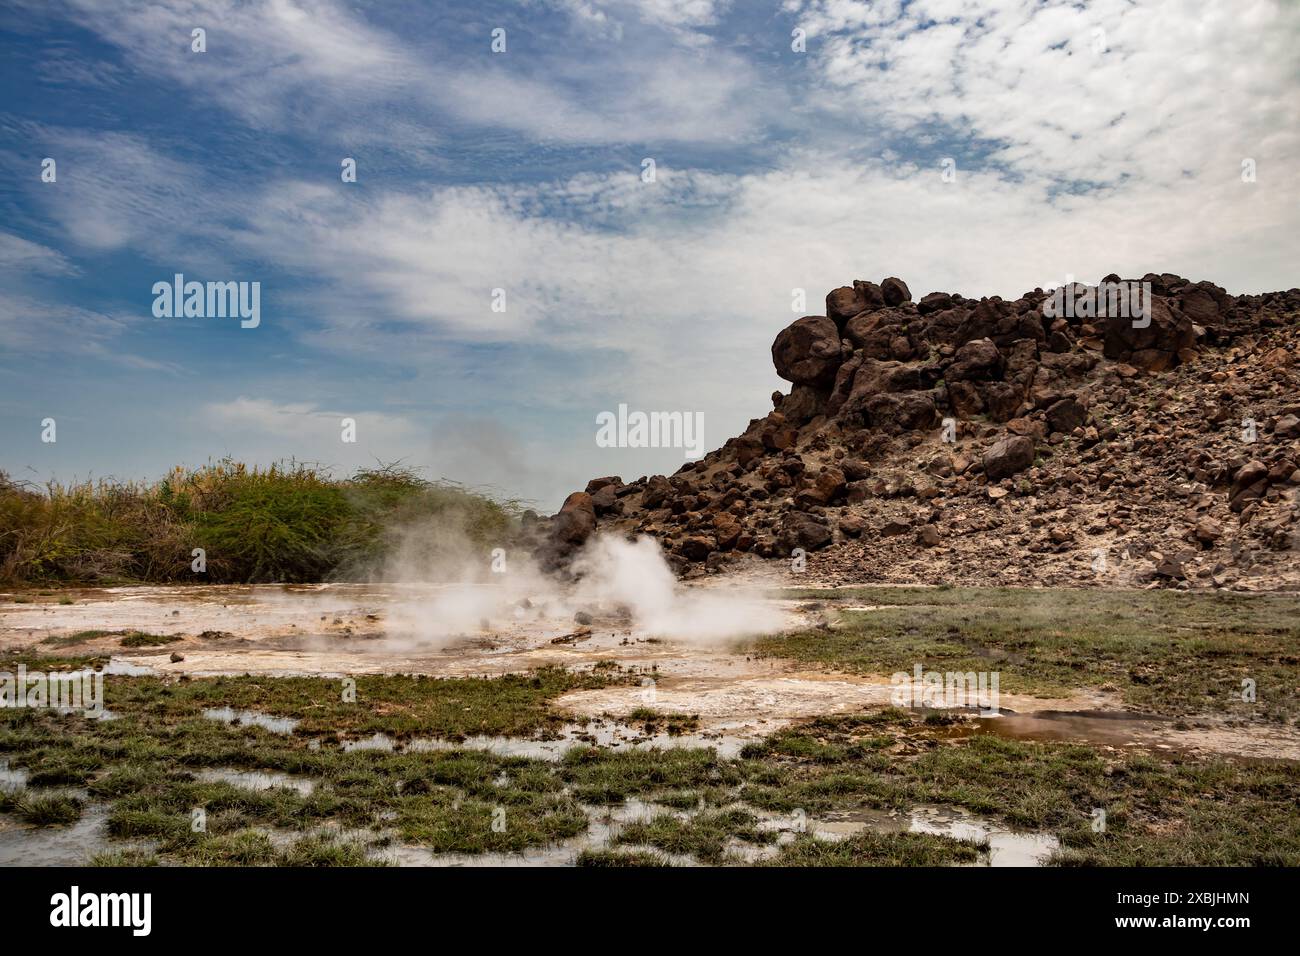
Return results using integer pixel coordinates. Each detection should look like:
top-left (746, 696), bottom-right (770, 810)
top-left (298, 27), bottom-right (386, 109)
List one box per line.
top-left (0, 584), bottom-right (1300, 760)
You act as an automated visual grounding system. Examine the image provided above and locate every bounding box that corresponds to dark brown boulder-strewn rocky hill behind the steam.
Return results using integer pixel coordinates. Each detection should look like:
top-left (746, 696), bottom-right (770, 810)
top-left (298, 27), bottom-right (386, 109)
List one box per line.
top-left (538, 274), bottom-right (1300, 588)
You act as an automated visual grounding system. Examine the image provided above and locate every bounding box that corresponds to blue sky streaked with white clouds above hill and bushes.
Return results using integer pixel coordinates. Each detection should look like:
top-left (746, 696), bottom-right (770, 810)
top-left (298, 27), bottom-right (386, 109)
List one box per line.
top-left (0, 0), bottom-right (1300, 511)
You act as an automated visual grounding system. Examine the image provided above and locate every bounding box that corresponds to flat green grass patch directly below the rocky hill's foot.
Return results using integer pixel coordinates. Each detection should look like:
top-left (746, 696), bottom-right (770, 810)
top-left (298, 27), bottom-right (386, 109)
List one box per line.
top-left (758, 588), bottom-right (1300, 721)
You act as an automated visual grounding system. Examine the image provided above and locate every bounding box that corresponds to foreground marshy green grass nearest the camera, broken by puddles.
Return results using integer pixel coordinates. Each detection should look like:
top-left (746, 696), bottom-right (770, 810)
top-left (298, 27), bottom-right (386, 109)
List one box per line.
top-left (0, 678), bottom-right (1300, 865)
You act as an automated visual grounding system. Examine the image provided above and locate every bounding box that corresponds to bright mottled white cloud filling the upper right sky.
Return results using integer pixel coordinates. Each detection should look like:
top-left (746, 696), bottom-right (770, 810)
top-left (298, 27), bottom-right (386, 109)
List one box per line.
top-left (797, 0), bottom-right (1300, 193)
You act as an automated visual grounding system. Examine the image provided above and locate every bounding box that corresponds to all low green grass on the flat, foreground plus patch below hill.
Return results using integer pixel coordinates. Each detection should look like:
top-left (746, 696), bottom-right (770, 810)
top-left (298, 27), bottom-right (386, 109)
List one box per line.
top-left (0, 613), bottom-right (1300, 866)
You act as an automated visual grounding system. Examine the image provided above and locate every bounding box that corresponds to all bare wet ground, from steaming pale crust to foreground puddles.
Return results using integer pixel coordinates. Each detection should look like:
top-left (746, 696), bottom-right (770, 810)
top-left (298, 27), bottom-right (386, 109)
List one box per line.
top-left (0, 584), bottom-right (1300, 866)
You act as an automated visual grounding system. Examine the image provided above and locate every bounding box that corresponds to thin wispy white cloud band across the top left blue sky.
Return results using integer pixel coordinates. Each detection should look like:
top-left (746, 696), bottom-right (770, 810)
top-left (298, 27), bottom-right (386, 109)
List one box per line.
top-left (55, 0), bottom-right (781, 148)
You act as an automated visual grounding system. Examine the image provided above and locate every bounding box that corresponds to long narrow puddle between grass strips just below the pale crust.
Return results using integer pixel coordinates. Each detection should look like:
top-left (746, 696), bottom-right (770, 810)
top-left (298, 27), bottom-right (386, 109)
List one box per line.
top-left (339, 723), bottom-right (758, 761)
